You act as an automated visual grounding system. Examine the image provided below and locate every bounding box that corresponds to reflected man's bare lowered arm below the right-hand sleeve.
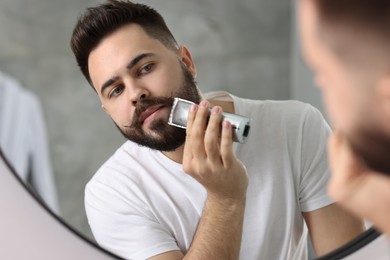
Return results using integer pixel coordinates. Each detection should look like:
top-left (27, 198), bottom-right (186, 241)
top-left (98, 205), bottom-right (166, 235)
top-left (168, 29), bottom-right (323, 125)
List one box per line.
top-left (303, 204), bottom-right (365, 256)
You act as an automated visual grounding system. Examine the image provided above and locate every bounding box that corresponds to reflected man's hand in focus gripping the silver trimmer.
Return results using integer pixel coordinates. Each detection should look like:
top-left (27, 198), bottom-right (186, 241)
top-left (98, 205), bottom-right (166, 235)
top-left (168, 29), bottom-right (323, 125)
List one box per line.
top-left (183, 100), bottom-right (248, 199)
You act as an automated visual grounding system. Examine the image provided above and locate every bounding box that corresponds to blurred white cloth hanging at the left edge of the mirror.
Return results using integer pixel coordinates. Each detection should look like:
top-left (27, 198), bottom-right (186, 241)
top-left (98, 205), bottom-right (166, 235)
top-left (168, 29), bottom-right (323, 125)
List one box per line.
top-left (0, 71), bottom-right (60, 214)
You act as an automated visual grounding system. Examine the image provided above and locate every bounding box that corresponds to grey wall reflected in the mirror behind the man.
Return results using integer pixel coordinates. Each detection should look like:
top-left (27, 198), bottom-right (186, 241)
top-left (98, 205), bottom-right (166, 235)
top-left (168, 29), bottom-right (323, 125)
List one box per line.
top-left (0, 0), bottom-right (378, 258)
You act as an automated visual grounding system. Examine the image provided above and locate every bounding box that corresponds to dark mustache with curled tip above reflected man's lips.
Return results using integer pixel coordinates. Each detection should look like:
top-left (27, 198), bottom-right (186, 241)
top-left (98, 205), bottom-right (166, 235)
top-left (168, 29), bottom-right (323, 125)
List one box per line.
top-left (124, 94), bottom-right (174, 128)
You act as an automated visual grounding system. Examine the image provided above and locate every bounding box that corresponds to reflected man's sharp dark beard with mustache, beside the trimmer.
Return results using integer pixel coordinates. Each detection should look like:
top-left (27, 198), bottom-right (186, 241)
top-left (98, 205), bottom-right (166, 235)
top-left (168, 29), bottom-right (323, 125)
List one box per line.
top-left (115, 65), bottom-right (201, 152)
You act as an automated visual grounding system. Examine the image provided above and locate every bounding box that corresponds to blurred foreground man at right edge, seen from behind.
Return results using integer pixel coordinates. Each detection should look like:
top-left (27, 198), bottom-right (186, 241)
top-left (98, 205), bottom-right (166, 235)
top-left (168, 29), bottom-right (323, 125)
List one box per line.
top-left (299, 0), bottom-right (390, 238)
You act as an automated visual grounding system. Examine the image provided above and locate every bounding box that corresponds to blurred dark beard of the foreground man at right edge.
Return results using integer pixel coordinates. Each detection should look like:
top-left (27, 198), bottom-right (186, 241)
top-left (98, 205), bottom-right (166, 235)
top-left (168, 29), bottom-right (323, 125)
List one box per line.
top-left (347, 124), bottom-right (390, 175)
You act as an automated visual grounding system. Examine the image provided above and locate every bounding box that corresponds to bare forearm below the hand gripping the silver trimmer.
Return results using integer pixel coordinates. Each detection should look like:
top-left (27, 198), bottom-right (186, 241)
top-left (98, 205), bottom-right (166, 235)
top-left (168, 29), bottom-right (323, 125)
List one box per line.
top-left (184, 195), bottom-right (245, 260)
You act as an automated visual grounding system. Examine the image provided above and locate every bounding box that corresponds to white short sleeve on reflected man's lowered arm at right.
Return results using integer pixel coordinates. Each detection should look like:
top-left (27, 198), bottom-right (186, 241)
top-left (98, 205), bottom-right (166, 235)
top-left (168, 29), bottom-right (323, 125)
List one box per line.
top-left (299, 106), bottom-right (333, 212)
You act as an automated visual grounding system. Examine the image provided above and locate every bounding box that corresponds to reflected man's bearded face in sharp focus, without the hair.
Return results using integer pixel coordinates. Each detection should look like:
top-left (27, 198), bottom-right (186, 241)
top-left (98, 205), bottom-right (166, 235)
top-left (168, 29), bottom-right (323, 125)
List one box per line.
top-left (88, 24), bottom-right (201, 151)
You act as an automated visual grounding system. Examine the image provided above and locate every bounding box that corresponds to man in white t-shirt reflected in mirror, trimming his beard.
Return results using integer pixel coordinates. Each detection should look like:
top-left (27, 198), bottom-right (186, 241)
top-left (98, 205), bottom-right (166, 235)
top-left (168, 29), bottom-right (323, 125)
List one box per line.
top-left (71, 1), bottom-right (363, 260)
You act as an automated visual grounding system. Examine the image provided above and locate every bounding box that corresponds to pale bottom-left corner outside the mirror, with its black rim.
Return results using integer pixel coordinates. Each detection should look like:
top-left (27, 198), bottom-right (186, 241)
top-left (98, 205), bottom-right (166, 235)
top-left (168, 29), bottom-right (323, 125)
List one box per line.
top-left (0, 149), bottom-right (121, 260)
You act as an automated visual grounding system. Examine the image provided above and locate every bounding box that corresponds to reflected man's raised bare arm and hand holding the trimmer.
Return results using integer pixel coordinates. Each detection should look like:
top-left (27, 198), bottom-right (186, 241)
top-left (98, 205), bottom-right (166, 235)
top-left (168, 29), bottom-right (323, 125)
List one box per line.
top-left (150, 101), bottom-right (248, 260)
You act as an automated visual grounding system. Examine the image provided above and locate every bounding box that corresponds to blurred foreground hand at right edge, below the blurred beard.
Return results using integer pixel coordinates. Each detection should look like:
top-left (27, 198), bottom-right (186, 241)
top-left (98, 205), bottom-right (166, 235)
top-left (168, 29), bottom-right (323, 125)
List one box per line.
top-left (328, 132), bottom-right (390, 237)
